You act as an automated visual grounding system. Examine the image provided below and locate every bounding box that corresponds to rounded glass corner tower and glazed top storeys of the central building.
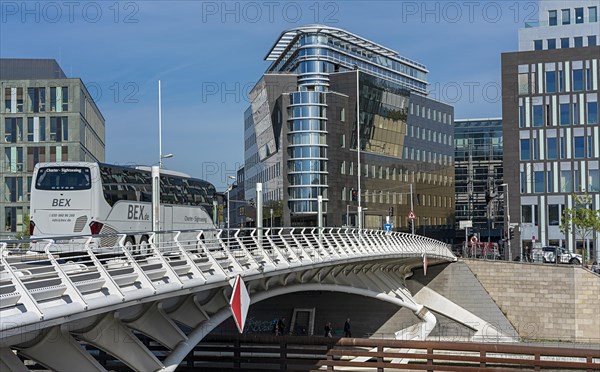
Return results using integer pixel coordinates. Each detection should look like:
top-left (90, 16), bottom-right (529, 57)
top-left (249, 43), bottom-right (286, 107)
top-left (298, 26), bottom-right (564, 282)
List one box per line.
top-left (266, 25), bottom-right (427, 218)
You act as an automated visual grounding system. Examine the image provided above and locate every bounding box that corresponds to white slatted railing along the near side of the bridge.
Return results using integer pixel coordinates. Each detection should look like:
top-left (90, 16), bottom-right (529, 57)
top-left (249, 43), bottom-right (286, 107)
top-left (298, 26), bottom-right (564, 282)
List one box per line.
top-left (0, 228), bottom-right (455, 333)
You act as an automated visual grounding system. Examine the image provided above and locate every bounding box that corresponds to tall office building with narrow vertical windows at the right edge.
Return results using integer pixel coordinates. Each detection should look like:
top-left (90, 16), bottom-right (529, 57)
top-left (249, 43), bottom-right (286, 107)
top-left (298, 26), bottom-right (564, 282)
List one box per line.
top-left (502, 0), bottom-right (600, 257)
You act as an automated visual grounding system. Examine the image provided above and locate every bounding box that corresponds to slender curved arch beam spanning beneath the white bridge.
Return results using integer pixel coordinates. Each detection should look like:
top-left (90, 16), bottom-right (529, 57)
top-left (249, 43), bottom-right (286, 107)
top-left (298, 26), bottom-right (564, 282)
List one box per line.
top-left (159, 283), bottom-right (437, 372)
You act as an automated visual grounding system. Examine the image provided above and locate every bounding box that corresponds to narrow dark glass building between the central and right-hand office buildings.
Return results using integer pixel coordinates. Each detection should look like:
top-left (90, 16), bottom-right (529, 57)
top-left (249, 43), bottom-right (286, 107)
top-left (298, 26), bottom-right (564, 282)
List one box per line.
top-left (454, 118), bottom-right (504, 243)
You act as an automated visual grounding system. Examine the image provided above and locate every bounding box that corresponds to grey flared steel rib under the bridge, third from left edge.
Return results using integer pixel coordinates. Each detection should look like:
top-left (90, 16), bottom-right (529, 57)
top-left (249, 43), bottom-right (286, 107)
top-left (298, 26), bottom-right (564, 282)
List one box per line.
top-left (77, 312), bottom-right (163, 371)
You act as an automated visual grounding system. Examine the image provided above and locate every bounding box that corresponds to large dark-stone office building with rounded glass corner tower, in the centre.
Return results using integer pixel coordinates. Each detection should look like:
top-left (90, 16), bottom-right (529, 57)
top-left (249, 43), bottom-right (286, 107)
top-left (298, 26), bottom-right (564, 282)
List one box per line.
top-left (244, 25), bottom-right (454, 238)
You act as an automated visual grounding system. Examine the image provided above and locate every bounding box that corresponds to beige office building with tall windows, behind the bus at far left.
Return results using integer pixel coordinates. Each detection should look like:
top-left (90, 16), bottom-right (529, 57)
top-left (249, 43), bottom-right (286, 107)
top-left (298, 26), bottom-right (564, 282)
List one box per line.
top-left (0, 58), bottom-right (105, 238)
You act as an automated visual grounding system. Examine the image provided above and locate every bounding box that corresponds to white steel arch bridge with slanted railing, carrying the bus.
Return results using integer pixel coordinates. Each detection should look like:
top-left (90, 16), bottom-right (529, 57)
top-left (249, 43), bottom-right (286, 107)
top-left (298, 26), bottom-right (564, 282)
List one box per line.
top-left (0, 228), bottom-right (456, 371)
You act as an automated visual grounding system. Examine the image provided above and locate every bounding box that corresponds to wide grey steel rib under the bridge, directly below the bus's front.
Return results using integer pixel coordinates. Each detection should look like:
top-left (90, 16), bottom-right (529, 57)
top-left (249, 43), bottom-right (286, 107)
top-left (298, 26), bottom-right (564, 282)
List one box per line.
top-left (20, 326), bottom-right (106, 371)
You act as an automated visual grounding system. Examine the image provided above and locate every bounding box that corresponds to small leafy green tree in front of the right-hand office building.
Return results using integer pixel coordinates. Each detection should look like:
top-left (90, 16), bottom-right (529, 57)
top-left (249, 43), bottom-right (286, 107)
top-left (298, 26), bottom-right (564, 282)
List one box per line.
top-left (560, 193), bottom-right (600, 263)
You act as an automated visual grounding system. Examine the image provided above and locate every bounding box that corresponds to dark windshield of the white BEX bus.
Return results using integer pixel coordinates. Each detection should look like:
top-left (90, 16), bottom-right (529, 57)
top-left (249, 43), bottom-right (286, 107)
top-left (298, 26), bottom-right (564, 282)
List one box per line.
top-left (35, 167), bottom-right (92, 190)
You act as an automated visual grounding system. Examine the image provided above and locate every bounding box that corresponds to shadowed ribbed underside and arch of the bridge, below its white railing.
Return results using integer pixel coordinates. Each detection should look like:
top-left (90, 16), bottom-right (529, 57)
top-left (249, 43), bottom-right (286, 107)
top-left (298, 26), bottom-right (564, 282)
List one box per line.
top-left (0, 259), bottom-right (448, 371)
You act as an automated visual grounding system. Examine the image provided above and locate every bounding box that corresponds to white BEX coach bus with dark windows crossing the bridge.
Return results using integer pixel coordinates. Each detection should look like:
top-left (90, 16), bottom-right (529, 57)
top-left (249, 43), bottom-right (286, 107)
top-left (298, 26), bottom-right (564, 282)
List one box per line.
top-left (30, 162), bottom-right (215, 253)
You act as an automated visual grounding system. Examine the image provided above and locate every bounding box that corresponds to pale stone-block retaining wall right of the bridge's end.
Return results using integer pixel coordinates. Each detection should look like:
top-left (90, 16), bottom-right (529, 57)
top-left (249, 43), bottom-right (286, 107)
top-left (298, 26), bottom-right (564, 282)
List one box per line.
top-left (464, 260), bottom-right (600, 343)
